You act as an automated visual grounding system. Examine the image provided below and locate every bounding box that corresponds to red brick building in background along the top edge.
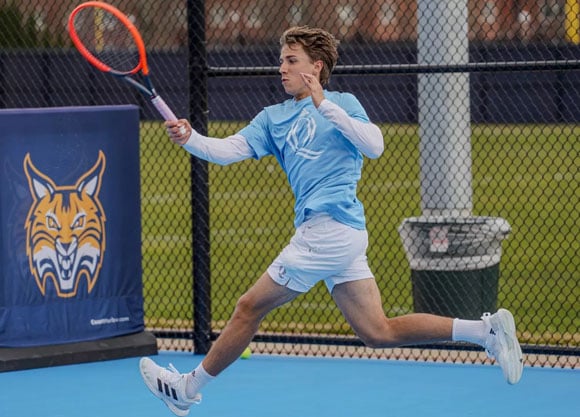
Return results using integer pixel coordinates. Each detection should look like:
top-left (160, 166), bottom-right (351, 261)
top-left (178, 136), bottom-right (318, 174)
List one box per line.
top-left (6, 0), bottom-right (578, 48)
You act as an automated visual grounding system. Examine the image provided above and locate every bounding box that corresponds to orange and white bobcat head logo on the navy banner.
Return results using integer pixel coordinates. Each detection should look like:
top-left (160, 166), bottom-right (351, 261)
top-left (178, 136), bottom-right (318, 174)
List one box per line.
top-left (24, 151), bottom-right (105, 298)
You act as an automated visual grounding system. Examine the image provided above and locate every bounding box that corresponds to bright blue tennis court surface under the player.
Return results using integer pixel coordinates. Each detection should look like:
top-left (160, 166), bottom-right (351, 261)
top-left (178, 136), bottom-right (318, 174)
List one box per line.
top-left (0, 352), bottom-right (580, 417)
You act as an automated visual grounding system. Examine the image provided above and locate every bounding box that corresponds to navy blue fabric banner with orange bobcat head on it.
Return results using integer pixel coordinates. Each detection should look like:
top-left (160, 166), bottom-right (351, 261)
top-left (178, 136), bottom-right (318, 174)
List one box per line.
top-left (0, 106), bottom-right (144, 347)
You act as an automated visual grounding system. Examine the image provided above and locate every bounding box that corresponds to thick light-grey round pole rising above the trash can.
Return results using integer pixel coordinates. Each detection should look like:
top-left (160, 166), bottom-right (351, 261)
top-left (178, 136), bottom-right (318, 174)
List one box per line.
top-left (417, 0), bottom-right (472, 217)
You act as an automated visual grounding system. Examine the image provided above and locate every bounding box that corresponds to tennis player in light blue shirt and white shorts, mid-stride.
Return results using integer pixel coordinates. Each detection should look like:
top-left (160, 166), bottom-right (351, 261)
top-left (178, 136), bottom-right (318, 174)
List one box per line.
top-left (140, 27), bottom-right (523, 416)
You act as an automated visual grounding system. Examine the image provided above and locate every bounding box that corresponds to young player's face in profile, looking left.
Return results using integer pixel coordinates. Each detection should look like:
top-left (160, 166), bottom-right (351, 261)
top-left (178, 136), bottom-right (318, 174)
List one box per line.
top-left (279, 43), bottom-right (322, 100)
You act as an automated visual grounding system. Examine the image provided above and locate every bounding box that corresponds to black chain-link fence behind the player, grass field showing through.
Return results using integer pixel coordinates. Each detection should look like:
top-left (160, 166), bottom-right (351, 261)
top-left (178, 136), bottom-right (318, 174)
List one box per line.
top-left (0, 0), bottom-right (580, 367)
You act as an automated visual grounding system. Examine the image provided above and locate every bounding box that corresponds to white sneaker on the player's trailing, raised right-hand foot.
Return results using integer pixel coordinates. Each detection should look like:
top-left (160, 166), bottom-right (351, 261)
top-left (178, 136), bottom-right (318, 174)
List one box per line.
top-left (481, 308), bottom-right (524, 384)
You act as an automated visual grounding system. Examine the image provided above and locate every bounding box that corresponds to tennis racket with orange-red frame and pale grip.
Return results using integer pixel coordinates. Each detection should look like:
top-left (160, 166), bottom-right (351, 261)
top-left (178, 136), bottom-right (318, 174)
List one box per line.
top-left (68, 1), bottom-right (185, 126)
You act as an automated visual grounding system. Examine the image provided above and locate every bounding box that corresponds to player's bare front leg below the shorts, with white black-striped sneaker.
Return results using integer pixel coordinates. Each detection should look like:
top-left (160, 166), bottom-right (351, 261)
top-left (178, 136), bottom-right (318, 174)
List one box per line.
top-left (139, 272), bottom-right (300, 416)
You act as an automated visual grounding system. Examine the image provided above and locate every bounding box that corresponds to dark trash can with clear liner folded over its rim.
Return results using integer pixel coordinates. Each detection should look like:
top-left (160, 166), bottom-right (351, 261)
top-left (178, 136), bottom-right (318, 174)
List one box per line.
top-left (399, 217), bottom-right (511, 319)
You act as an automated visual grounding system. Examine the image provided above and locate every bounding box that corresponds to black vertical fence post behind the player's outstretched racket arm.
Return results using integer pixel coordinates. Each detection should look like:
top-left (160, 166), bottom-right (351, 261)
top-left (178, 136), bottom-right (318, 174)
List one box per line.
top-left (187, 0), bottom-right (211, 354)
